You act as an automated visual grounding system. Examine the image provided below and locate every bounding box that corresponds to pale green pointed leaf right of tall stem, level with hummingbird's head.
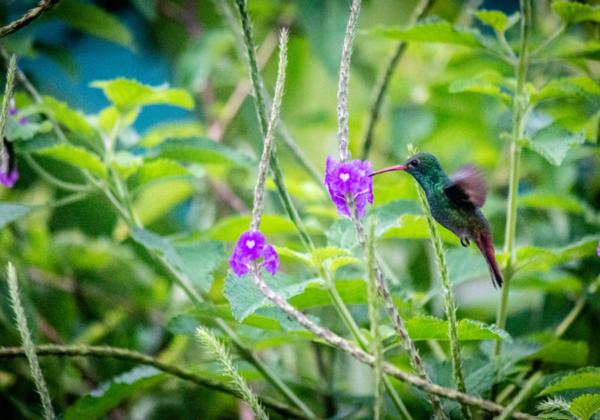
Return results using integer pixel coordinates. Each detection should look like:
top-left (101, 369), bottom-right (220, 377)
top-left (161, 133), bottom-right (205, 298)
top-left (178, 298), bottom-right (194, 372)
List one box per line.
top-left (525, 125), bottom-right (585, 166)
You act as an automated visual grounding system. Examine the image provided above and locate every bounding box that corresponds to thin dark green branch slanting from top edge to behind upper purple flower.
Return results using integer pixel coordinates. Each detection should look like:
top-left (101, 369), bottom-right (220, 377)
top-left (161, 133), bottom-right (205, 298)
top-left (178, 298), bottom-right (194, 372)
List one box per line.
top-left (361, 0), bottom-right (435, 160)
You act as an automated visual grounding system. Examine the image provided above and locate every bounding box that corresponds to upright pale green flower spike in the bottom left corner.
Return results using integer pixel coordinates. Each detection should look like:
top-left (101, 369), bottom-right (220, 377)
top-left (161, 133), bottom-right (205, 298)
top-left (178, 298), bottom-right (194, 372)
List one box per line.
top-left (7, 263), bottom-right (55, 420)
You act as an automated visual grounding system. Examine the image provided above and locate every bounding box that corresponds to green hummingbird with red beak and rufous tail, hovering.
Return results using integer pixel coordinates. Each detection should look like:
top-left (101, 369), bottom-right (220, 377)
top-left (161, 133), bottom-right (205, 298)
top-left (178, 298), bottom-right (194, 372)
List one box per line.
top-left (370, 153), bottom-right (503, 287)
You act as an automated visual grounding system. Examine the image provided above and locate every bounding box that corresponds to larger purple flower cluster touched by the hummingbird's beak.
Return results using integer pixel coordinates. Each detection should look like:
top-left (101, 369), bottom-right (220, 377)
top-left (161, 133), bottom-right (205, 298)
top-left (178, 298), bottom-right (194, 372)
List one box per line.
top-left (324, 157), bottom-right (373, 217)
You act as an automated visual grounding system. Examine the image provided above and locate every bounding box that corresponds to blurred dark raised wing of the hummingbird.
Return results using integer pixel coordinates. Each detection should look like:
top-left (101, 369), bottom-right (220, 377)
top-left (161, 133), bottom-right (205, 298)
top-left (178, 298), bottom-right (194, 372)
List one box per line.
top-left (444, 165), bottom-right (487, 208)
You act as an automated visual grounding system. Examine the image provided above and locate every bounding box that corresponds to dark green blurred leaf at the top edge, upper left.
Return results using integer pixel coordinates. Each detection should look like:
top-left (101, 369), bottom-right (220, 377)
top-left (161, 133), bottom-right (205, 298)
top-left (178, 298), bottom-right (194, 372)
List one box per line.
top-left (52, 1), bottom-right (133, 48)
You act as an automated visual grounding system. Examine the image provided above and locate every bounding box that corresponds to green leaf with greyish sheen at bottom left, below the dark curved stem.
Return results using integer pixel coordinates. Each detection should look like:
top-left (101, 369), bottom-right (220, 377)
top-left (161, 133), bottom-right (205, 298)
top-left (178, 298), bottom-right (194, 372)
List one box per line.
top-left (64, 366), bottom-right (167, 420)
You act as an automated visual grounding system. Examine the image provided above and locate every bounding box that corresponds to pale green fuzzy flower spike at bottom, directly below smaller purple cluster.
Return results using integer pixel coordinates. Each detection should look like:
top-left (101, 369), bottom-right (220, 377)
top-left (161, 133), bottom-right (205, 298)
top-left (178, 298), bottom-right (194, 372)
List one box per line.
top-left (196, 327), bottom-right (269, 420)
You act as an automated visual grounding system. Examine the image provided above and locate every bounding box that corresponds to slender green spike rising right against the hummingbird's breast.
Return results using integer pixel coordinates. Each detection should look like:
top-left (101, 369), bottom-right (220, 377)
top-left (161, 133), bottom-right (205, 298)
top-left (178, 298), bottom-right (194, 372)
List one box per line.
top-left (415, 182), bottom-right (472, 419)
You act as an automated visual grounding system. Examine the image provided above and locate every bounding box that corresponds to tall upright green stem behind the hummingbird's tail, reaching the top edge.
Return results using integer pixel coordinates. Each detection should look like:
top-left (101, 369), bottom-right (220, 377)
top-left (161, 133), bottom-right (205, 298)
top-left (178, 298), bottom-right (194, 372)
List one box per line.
top-left (495, 0), bottom-right (531, 356)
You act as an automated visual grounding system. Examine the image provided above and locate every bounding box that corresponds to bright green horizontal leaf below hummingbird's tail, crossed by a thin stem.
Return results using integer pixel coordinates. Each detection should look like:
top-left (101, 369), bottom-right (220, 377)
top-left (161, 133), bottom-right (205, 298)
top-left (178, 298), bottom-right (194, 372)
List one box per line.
top-left (406, 316), bottom-right (511, 341)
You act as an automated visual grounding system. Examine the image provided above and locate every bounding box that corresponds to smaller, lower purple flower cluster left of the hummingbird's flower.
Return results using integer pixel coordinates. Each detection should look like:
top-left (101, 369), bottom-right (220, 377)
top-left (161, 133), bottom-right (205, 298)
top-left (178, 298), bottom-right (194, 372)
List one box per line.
top-left (229, 231), bottom-right (279, 276)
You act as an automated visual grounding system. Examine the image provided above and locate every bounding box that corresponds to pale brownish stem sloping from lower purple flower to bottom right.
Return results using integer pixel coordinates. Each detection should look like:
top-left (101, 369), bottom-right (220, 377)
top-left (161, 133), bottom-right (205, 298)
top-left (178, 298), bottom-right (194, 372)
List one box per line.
top-left (246, 267), bottom-right (534, 420)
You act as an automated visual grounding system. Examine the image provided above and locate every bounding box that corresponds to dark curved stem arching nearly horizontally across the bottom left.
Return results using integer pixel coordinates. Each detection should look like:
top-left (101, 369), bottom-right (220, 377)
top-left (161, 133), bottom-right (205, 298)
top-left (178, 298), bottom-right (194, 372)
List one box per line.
top-left (0, 344), bottom-right (307, 418)
